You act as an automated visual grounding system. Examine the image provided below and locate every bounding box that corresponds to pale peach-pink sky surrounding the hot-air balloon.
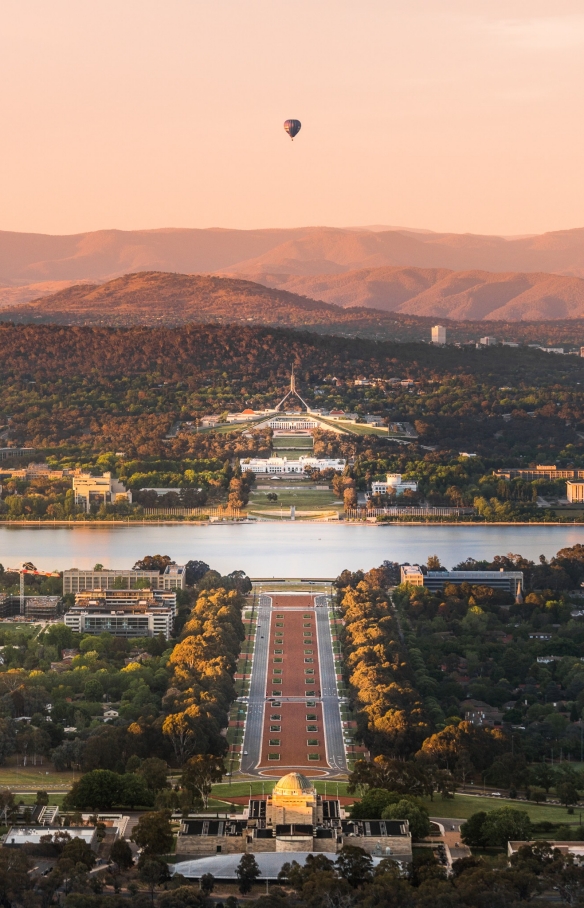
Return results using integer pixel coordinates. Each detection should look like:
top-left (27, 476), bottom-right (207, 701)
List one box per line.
top-left (0, 0), bottom-right (584, 234)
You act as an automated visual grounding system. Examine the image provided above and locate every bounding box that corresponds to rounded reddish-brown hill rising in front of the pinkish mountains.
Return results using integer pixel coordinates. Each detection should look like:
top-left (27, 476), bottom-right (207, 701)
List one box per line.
top-left (6, 271), bottom-right (584, 346)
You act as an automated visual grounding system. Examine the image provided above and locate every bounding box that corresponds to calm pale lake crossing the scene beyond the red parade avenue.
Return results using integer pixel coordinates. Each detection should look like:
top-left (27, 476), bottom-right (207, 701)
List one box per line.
top-left (0, 523), bottom-right (584, 577)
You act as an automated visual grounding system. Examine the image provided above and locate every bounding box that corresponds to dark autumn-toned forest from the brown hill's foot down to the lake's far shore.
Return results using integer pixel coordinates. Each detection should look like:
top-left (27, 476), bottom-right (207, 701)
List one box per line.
top-left (0, 325), bottom-right (584, 520)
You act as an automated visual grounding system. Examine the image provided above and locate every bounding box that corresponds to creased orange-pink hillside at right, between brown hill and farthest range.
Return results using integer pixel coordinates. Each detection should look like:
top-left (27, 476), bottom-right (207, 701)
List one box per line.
top-left (264, 267), bottom-right (584, 321)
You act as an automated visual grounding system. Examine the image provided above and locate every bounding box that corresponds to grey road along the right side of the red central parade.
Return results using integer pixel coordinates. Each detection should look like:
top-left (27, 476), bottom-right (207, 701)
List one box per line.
top-left (315, 596), bottom-right (347, 772)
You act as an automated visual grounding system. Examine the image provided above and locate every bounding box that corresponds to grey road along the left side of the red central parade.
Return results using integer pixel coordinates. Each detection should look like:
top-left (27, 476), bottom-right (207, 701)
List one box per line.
top-left (241, 594), bottom-right (272, 773)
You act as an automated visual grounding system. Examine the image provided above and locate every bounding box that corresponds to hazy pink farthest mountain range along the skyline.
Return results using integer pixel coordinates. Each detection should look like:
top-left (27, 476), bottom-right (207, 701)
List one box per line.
top-left (0, 227), bottom-right (584, 290)
